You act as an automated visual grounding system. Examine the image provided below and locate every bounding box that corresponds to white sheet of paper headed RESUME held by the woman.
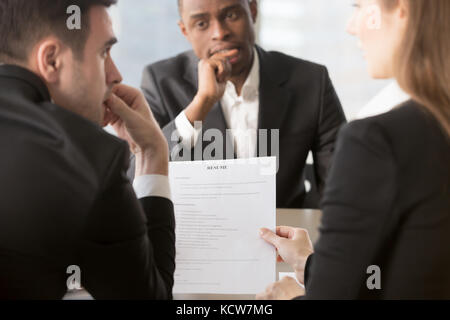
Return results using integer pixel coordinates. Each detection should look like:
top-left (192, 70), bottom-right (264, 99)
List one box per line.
top-left (169, 157), bottom-right (277, 294)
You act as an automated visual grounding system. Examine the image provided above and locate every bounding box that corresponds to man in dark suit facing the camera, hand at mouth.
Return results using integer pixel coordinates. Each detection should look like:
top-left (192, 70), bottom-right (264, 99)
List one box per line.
top-left (142, 0), bottom-right (345, 208)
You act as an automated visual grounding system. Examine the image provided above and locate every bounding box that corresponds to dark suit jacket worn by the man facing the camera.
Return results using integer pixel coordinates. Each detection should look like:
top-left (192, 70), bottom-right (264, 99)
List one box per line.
top-left (142, 47), bottom-right (346, 208)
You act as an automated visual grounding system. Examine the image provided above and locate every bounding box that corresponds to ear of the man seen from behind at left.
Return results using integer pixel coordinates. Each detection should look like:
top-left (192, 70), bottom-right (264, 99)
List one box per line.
top-left (36, 38), bottom-right (63, 83)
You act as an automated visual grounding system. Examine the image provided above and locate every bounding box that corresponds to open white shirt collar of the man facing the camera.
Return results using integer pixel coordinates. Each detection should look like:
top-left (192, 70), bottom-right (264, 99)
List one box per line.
top-left (224, 48), bottom-right (260, 101)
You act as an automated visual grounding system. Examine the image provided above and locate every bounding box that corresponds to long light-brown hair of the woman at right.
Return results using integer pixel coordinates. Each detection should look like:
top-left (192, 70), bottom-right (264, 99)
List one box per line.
top-left (381, 0), bottom-right (450, 137)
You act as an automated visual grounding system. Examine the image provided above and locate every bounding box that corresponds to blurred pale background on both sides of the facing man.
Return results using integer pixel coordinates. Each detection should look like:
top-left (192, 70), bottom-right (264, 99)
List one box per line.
top-left (111, 0), bottom-right (389, 119)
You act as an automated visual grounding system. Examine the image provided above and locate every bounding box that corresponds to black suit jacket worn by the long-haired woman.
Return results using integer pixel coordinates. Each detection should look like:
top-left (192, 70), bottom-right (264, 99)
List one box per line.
top-left (300, 101), bottom-right (450, 299)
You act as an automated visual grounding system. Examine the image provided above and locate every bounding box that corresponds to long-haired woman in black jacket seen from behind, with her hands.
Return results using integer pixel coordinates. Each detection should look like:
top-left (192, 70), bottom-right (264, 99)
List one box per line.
top-left (257, 0), bottom-right (450, 299)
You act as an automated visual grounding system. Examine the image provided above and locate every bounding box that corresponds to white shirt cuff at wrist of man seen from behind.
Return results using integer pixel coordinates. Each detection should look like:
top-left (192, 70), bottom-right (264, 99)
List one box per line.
top-left (133, 174), bottom-right (171, 200)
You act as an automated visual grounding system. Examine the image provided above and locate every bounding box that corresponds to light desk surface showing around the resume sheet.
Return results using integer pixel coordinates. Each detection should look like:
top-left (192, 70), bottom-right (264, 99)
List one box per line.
top-left (65, 209), bottom-right (322, 300)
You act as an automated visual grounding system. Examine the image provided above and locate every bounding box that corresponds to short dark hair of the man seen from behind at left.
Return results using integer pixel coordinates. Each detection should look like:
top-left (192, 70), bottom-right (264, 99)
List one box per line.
top-left (0, 0), bottom-right (117, 62)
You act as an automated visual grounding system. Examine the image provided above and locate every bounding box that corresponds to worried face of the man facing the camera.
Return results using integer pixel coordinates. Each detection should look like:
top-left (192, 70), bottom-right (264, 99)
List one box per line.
top-left (179, 0), bottom-right (257, 76)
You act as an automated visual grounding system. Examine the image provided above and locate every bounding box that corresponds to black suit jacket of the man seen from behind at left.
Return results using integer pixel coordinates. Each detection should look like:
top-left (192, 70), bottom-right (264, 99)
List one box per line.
top-left (0, 65), bottom-right (175, 299)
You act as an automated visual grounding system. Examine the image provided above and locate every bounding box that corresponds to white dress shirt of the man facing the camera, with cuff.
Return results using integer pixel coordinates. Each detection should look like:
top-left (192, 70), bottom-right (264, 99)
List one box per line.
top-left (175, 49), bottom-right (260, 158)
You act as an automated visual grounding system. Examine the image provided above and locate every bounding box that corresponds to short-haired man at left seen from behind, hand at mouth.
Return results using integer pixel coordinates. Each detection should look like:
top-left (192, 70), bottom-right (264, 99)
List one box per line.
top-left (0, 0), bottom-right (175, 299)
